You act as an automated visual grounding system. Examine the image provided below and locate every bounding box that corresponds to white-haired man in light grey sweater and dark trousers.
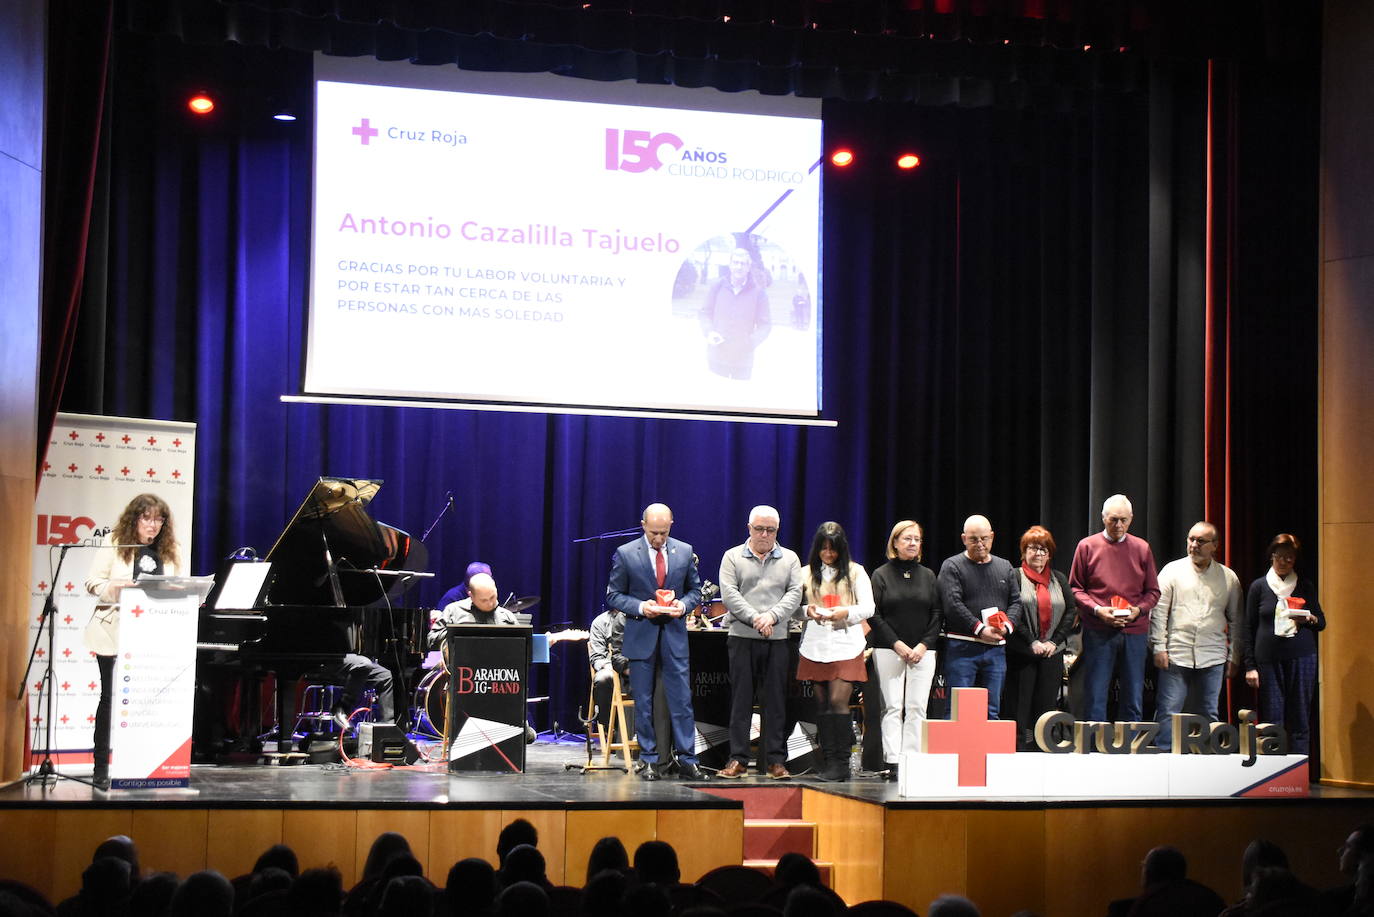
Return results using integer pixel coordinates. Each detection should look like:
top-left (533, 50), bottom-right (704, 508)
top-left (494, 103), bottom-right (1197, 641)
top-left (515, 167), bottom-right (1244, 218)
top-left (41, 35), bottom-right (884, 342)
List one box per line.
top-left (720, 506), bottom-right (801, 780)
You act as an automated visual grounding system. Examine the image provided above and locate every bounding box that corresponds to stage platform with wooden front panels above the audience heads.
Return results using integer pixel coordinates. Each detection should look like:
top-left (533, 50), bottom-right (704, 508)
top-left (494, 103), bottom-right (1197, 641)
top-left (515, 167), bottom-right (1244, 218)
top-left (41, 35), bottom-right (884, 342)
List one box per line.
top-left (0, 741), bottom-right (1374, 914)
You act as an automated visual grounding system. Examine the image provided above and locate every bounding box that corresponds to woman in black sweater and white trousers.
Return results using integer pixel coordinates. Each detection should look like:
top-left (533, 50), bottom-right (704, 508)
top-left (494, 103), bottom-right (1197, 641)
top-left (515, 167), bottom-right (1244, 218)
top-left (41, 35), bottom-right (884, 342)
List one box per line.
top-left (868, 520), bottom-right (944, 780)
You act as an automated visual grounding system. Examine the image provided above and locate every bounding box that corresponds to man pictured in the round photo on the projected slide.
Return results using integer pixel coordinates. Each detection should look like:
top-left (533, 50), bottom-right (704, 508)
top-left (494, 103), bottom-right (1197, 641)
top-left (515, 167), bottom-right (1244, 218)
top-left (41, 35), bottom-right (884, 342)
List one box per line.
top-left (698, 247), bottom-right (772, 379)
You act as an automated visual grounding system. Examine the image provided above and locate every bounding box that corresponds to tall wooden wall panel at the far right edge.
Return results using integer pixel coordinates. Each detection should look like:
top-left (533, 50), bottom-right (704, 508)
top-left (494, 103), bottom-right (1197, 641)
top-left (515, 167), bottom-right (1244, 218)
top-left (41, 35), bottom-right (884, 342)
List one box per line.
top-left (1318, 0), bottom-right (1374, 786)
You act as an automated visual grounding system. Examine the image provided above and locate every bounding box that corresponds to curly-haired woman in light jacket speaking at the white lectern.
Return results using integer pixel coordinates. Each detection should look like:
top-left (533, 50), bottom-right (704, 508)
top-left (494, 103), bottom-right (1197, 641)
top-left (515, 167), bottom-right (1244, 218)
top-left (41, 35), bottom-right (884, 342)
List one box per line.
top-left (85, 494), bottom-right (181, 789)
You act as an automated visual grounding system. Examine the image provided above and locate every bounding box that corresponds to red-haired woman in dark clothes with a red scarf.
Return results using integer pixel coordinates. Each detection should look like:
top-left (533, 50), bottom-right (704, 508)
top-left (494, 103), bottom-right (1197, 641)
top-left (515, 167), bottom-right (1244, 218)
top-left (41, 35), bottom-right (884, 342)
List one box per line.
top-left (1002, 525), bottom-right (1079, 751)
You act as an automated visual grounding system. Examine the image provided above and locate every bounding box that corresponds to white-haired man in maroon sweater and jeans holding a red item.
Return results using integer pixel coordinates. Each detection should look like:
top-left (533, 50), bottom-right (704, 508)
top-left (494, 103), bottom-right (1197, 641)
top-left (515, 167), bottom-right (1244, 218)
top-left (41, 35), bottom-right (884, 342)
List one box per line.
top-left (1069, 494), bottom-right (1160, 722)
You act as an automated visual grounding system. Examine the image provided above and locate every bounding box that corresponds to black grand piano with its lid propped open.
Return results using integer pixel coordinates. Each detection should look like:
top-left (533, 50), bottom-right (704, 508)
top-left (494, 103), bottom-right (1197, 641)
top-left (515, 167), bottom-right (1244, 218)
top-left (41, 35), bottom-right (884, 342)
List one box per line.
top-left (196, 477), bottom-right (429, 752)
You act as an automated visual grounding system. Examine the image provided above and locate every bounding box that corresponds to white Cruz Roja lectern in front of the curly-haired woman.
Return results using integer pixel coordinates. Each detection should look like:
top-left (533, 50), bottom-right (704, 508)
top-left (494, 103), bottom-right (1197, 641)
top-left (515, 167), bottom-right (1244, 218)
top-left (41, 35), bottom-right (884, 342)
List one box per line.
top-left (110, 576), bottom-right (214, 789)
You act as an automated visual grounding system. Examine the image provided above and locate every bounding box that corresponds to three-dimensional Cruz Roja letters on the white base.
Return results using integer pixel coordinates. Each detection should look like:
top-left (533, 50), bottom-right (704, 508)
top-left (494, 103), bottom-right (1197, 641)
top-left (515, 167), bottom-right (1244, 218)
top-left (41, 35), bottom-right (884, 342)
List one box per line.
top-left (1035, 709), bottom-right (1287, 767)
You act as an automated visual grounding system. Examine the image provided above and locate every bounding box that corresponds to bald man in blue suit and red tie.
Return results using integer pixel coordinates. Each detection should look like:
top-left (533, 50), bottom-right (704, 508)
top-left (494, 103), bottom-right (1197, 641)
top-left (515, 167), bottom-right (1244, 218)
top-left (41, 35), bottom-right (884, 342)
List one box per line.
top-left (606, 503), bottom-right (703, 780)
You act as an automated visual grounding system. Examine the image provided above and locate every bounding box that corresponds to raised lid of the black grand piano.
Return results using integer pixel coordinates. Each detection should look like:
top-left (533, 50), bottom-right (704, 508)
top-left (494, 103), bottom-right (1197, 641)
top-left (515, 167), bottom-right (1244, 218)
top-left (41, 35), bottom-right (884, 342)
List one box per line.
top-left (267, 477), bottom-right (425, 605)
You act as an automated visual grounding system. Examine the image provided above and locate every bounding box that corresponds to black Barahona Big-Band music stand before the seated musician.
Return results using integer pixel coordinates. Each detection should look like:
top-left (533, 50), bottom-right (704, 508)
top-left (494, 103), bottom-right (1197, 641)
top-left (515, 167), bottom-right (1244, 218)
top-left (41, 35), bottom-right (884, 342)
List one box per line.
top-left (444, 624), bottom-right (533, 774)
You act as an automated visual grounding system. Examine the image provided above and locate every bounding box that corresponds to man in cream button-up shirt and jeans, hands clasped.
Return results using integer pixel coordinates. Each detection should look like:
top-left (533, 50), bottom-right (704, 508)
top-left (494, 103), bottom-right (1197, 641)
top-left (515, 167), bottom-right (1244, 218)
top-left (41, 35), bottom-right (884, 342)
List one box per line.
top-left (1150, 522), bottom-right (1241, 751)
